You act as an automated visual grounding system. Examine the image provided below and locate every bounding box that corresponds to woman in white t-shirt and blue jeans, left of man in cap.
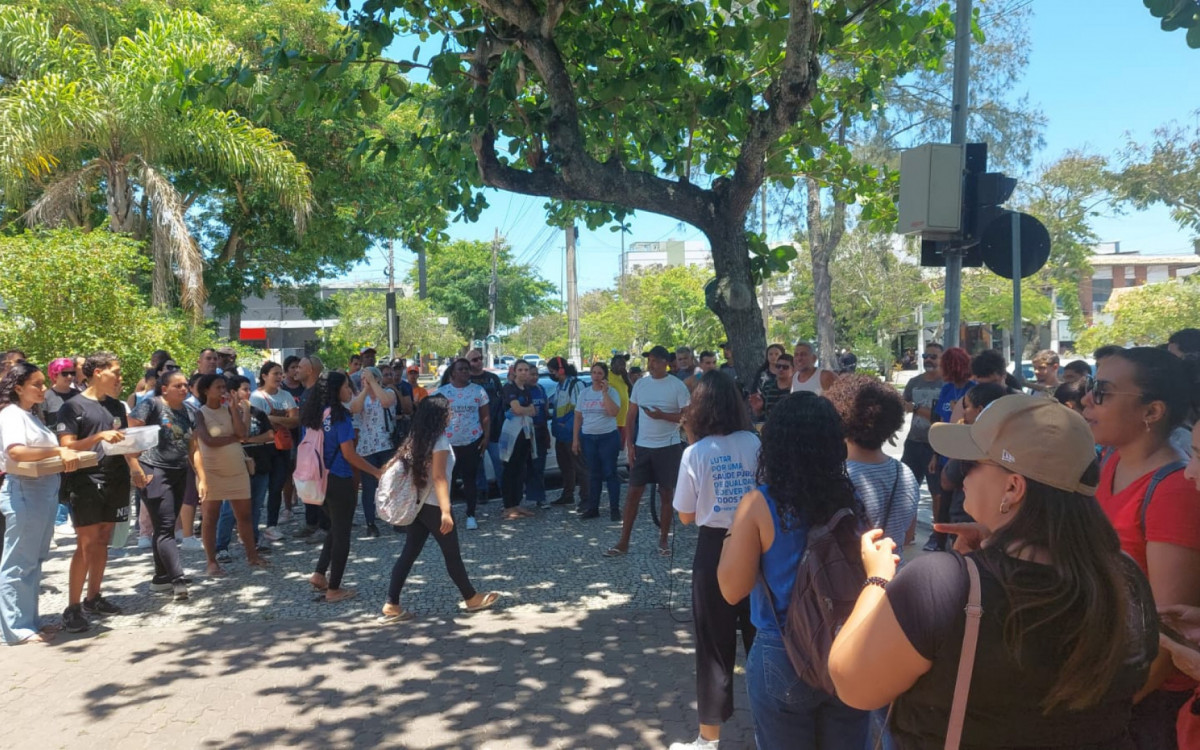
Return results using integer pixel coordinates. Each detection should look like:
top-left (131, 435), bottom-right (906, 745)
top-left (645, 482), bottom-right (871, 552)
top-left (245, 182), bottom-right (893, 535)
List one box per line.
top-left (571, 362), bottom-right (620, 521)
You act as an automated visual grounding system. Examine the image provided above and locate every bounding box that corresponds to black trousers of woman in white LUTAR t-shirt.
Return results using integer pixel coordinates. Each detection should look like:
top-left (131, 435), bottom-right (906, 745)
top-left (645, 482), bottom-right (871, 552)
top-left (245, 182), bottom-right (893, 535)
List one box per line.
top-left (691, 526), bottom-right (755, 725)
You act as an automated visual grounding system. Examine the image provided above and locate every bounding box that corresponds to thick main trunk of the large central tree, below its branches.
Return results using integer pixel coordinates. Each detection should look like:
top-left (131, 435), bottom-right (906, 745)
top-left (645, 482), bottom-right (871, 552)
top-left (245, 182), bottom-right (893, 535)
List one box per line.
top-left (704, 216), bottom-right (767, 389)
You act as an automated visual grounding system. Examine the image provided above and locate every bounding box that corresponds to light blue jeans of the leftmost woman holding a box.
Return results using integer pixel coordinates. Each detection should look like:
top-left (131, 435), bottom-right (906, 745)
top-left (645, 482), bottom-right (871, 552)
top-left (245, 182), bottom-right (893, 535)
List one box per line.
top-left (0, 474), bottom-right (61, 643)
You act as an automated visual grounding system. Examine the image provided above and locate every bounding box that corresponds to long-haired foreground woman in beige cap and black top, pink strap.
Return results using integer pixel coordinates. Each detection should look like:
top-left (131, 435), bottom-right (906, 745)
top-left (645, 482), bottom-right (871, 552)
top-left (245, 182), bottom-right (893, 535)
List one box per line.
top-left (829, 395), bottom-right (1158, 749)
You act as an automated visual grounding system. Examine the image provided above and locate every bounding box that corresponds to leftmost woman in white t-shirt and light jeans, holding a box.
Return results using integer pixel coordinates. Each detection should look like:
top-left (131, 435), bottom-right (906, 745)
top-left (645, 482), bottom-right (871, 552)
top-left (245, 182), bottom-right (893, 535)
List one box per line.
top-left (0, 361), bottom-right (79, 646)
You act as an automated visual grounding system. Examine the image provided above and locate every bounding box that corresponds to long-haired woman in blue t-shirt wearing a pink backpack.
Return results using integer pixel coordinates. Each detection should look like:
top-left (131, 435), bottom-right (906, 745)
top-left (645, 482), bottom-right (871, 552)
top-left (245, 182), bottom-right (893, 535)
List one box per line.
top-left (300, 370), bottom-right (380, 602)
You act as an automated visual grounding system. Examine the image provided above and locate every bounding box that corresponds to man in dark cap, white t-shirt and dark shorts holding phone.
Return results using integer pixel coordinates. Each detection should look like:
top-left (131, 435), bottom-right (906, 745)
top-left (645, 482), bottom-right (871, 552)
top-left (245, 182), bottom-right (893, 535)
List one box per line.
top-left (604, 346), bottom-right (691, 557)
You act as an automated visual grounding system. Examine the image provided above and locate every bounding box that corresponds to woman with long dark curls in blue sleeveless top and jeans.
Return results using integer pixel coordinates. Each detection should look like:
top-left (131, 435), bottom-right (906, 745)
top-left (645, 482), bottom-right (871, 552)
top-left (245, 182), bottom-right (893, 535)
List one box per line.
top-left (716, 391), bottom-right (868, 750)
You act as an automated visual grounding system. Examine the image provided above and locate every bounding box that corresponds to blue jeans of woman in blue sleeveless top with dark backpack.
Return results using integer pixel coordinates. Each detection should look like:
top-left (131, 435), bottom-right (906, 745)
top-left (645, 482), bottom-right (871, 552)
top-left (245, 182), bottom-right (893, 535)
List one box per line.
top-left (746, 630), bottom-right (870, 750)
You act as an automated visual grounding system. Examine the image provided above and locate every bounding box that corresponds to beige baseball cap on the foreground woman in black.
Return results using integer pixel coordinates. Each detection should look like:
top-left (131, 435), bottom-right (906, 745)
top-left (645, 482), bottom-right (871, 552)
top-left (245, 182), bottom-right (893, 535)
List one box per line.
top-left (929, 394), bottom-right (1096, 496)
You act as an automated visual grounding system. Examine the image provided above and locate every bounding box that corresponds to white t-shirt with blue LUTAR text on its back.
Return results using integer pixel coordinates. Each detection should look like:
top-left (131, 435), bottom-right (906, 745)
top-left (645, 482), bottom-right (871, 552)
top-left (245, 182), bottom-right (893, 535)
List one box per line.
top-left (672, 431), bottom-right (761, 529)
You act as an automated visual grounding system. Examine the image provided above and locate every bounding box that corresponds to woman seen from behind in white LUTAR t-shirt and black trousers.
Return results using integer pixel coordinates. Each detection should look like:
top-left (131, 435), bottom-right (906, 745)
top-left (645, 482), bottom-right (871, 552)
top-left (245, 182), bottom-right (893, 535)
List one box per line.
top-left (671, 371), bottom-right (760, 750)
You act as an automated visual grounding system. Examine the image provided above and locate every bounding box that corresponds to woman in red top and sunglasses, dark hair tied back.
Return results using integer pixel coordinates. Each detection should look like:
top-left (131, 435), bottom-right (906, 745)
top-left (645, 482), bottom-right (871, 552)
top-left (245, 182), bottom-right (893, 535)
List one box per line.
top-left (1084, 347), bottom-right (1200, 749)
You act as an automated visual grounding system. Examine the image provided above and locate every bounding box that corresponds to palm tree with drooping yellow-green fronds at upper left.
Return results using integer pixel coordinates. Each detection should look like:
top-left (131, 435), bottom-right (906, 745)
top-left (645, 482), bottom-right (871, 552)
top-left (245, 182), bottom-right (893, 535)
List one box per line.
top-left (0, 6), bottom-right (312, 317)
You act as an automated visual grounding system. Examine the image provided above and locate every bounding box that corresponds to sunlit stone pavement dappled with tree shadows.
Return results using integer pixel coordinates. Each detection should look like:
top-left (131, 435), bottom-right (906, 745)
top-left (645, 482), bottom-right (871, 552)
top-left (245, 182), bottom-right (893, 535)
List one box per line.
top-left (0, 424), bottom-right (928, 750)
